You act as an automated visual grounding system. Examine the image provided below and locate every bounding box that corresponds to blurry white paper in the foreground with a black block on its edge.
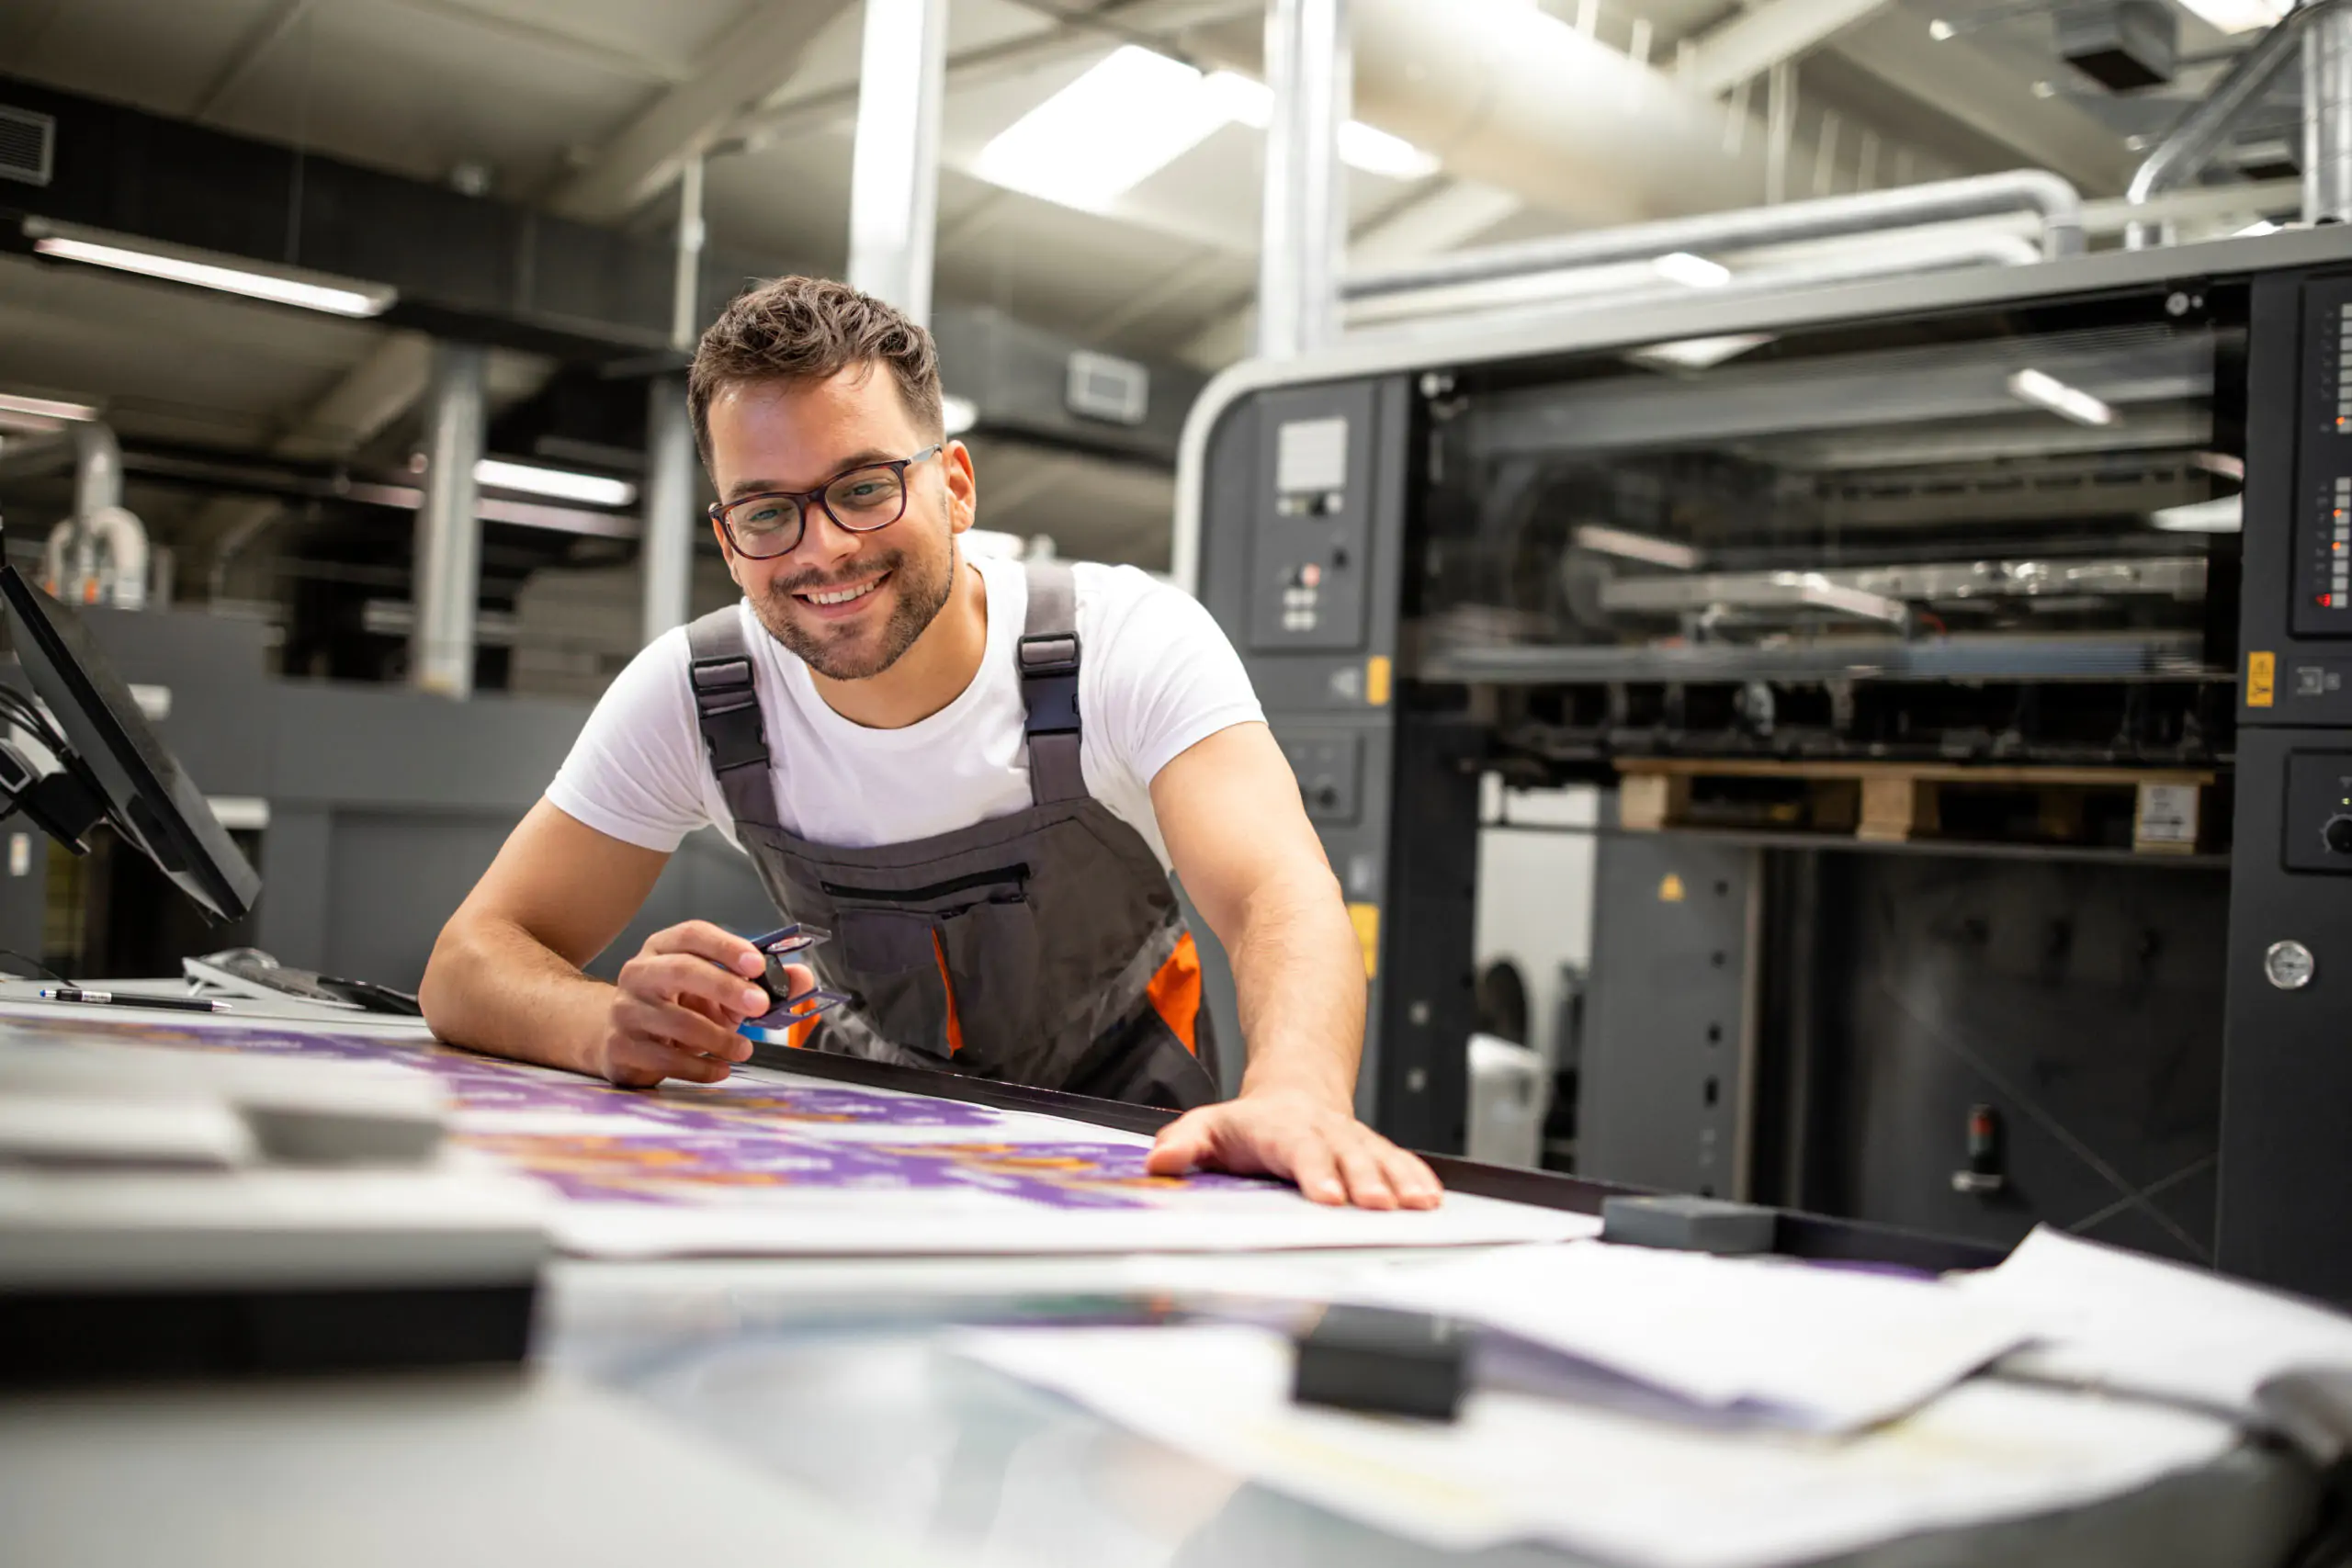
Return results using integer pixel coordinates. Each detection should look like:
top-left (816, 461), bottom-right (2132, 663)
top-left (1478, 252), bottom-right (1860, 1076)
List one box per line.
top-left (959, 1325), bottom-right (2237, 1568)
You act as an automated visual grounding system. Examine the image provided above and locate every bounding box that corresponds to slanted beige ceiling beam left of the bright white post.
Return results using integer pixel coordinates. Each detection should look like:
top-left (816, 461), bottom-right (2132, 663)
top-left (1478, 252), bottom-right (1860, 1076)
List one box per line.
top-left (550, 0), bottom-right (849, 223)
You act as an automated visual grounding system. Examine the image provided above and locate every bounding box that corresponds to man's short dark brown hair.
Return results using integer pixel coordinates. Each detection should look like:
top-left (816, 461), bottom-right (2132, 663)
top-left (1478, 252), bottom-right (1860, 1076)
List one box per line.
top-left (687, 277), bottom-right (945, 468)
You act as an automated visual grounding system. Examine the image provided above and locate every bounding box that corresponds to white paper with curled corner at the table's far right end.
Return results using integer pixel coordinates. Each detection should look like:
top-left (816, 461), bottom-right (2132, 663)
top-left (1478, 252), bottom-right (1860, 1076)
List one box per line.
top-left (1952, 1224), bottom-right (2352, 1413)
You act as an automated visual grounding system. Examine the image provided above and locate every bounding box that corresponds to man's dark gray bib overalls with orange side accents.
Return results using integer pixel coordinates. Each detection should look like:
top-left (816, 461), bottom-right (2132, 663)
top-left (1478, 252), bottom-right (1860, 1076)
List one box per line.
top-left (687, 562), bottom-right (1218, 1110)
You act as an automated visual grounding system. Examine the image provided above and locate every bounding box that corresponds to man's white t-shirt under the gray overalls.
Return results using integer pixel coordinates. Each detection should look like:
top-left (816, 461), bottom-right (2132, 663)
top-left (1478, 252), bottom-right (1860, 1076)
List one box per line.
top-left (548, 559), bottom-right (1265, 865)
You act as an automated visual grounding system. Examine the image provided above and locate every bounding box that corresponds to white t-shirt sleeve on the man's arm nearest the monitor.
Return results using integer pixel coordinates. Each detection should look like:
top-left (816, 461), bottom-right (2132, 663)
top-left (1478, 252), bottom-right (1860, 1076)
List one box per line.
top-left (548, 627), bottom-right (710, 853)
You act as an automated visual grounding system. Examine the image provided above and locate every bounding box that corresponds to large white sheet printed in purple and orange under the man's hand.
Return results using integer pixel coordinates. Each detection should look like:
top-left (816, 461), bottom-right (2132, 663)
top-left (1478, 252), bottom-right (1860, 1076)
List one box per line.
top-left (0, 1009), bottom-right (1597, 1258)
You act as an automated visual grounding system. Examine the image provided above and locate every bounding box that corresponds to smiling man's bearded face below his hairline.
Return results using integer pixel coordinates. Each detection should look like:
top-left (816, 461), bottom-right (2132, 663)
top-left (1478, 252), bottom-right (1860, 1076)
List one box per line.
top-left (708, 365), bottom-right (974, 680)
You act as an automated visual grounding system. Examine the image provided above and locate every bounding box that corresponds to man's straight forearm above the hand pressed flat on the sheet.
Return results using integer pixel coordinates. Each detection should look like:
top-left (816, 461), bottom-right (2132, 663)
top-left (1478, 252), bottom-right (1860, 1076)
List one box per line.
top-left (1227, 879), bottom-right (1364, 1110)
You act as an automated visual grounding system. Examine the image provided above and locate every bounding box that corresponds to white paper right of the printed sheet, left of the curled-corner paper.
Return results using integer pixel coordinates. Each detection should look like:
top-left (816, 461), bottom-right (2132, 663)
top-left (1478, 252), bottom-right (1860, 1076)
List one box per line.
top-left (1343, 1241), bottom-right (2025, 1432)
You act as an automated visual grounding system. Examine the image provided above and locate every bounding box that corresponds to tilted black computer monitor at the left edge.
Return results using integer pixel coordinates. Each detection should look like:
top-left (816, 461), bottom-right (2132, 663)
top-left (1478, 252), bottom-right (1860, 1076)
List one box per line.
top-left (0, 564), bottom-right (261, 924)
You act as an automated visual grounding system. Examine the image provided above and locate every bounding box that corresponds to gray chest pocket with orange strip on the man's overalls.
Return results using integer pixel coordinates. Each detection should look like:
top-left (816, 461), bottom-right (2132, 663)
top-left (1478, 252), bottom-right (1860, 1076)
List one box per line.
top-left (819, 865), bottom-right (1040, 1075)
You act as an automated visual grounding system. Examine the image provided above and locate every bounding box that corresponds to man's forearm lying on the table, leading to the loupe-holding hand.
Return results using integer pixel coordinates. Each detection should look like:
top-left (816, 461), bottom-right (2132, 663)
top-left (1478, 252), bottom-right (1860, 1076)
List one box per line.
top-left (419, 917), bottom-right (612, 1072)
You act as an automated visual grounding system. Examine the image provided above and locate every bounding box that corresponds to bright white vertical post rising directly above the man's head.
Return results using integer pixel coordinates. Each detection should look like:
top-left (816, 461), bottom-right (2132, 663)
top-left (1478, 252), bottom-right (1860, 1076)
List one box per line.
top-left (849, 0), bottom-right (948, 327)
